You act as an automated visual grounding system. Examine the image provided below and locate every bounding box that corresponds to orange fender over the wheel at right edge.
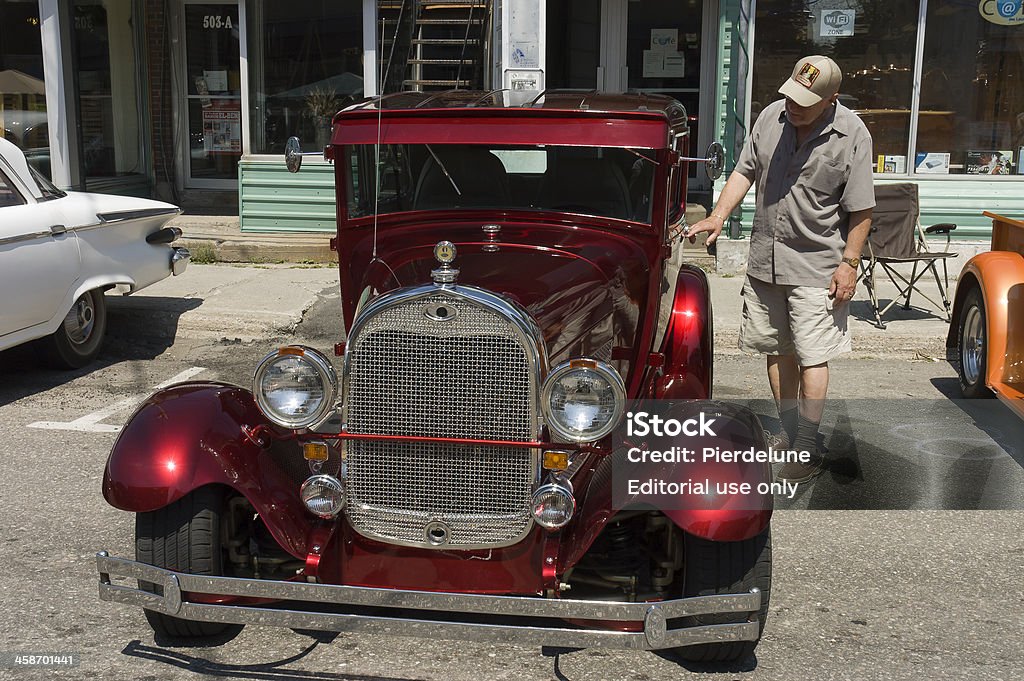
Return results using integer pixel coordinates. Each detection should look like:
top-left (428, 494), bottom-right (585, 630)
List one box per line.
top-left (946, 251), bottom-right (1024, 386)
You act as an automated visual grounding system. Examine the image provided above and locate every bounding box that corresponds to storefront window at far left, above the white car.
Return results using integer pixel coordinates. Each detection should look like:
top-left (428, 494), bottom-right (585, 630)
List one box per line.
top-left (0, 0), bottom-right (51, 177)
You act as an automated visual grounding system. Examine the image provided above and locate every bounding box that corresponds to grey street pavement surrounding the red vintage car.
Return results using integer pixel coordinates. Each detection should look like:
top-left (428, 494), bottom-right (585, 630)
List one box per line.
top-left (0, 264), bottom-right (1024, 681)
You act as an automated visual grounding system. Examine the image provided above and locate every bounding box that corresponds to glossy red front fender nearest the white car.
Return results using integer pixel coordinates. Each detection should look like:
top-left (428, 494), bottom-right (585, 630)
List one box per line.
top-left (103, 383), bottom-right (313, 559)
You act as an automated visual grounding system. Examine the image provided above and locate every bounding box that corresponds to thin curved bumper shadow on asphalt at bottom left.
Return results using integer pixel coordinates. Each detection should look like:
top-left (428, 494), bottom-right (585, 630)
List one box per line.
top-left (121, 632), bottom-right (403, 681)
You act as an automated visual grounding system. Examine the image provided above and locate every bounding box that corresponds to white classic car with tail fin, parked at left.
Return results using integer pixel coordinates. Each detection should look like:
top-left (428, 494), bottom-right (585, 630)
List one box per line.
top-left (0, 139), bottom-right (188, 369)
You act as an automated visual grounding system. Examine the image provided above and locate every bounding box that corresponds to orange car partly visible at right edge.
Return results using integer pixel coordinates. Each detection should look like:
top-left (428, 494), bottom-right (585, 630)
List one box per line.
top-left (946, 212), bottom-right (1024, 418)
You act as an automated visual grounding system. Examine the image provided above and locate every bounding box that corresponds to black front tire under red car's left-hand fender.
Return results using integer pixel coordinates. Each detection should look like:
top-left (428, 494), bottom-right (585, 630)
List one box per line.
top-left (135, 485), bottom-right (242, 639)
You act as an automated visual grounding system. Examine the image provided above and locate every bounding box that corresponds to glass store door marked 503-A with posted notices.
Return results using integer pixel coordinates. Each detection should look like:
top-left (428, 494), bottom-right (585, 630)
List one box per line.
top-left (180, 0), bottom-right (242, 189)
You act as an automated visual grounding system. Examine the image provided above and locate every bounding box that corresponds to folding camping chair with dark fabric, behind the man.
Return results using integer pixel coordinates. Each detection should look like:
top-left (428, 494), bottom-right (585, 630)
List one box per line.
top-left (859, 182), bottom-right (956, 329)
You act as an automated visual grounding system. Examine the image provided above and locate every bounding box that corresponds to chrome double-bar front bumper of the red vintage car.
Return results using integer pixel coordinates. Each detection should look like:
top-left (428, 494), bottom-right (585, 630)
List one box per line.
top-left (96, 551), bottom-right (761, 650)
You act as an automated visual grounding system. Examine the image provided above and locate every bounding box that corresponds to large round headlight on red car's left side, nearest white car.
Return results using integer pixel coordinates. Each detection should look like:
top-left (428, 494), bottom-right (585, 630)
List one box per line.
top-left (253, 345), bottom-right (338, 430)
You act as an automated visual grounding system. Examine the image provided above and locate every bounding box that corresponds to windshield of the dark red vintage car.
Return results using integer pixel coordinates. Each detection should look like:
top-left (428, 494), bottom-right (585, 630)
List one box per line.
top-left (347, 144), bottom-right (656, 224)
